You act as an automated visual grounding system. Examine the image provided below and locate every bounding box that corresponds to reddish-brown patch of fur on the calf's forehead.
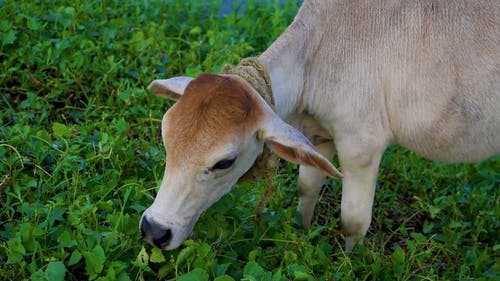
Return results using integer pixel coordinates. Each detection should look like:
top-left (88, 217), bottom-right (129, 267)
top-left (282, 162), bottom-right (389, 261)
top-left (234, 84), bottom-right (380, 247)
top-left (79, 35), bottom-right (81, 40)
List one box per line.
top-left (164, 74), bottom-right (262, 163)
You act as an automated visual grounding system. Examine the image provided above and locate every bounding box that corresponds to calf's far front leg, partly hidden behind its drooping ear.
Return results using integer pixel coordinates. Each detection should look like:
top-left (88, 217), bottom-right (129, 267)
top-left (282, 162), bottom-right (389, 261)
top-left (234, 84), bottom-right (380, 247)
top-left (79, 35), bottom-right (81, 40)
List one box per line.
top-left (297, 142), bottom-right (335, 229)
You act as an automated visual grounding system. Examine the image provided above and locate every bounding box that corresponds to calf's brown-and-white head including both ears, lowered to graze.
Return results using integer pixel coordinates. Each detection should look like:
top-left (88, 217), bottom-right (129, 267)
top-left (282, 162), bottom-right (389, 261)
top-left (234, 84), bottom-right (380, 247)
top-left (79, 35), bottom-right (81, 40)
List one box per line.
top-left (140, 74), bottom-right (341, 249)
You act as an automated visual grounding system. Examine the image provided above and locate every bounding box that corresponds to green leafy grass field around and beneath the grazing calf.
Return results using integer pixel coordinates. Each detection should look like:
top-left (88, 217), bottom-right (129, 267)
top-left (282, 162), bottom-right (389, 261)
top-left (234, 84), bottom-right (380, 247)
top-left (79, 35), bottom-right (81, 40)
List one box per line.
top-left (0, 0), bottom-right (500, 281)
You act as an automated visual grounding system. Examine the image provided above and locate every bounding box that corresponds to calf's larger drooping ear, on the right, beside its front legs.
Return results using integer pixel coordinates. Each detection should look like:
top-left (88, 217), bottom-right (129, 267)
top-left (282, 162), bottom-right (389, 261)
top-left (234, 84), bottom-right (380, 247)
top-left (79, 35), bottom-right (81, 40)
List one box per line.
top-left (258, 117), bottom-right (343, 179)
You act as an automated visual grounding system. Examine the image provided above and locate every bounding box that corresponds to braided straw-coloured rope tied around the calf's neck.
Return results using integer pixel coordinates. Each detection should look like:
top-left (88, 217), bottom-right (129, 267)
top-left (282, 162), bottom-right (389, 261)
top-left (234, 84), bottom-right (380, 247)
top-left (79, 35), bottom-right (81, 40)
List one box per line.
top-left (222, 57), bottom-right (278, 224)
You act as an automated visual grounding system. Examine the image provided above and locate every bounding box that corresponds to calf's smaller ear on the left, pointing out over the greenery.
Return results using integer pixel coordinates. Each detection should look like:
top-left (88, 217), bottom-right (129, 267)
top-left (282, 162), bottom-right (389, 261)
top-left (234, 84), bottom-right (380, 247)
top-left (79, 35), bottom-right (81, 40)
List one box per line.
top-left (148, 76), bottom-right (194, 100)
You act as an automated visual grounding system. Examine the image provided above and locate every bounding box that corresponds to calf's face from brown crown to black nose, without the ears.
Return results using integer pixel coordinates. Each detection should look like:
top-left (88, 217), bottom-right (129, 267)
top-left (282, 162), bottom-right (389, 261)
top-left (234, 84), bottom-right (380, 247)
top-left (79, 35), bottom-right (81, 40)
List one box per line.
top-left (141, 75), bottom-right (263, 249)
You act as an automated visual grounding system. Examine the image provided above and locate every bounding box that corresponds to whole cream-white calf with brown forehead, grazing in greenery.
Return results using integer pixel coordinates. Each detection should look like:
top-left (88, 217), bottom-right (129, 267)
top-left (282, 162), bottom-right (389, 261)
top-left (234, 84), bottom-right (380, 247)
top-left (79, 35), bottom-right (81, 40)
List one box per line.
top-left (140, 0), bottom-right (500, 249)
